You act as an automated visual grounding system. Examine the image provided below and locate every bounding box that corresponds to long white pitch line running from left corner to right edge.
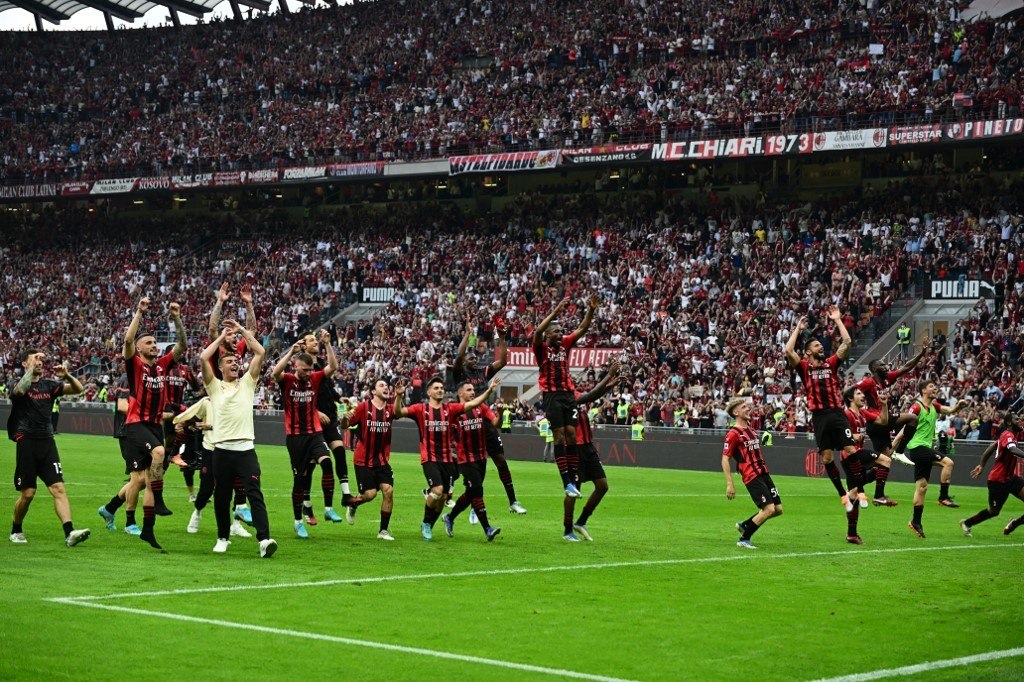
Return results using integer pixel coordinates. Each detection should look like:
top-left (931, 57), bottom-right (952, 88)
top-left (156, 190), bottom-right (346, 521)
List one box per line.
top-left (44, 543), bottom-right (1024, 603)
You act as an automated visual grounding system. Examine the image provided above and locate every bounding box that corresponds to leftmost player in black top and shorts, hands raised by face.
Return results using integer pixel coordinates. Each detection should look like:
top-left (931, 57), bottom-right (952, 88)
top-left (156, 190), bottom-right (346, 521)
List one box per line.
top-left (7, 348), bottom-right (89, 547)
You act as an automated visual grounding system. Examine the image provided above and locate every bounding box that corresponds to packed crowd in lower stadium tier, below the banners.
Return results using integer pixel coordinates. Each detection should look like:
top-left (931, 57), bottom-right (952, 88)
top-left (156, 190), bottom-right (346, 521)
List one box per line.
top-left (0, 171), bottom-right (1024, 437)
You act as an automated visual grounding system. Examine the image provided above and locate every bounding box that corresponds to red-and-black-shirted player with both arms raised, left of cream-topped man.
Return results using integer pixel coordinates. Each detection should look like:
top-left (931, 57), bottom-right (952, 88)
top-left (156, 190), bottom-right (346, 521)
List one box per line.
top-left (122, 297), bottom-right (185, 549)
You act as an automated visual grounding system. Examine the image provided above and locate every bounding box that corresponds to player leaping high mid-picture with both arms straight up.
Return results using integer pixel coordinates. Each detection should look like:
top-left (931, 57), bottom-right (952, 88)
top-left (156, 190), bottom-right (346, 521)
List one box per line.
top-left (532, 296), bottom-right (600, 498)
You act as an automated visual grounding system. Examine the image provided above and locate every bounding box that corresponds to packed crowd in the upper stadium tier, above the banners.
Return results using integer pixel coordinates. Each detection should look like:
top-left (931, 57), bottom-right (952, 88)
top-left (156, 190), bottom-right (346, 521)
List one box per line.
top-left (0, 0), bottom-right (1021, 183)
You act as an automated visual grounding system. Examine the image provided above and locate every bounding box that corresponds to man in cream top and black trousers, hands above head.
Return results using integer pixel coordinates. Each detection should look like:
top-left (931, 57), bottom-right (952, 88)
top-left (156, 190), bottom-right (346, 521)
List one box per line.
top-left (200, 321), bottom-right (278, 557)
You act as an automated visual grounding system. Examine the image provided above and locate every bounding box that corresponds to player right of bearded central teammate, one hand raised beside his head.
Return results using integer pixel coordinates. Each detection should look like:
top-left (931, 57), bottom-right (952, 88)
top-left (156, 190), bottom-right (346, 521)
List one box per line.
top-left (440, 377), bottom-right (503, 542)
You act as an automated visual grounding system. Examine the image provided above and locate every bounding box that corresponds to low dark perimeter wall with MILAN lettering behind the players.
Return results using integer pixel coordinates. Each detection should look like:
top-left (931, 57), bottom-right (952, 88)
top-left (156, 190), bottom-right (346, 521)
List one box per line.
top-left (0, 403), bottom-right (1003, 485)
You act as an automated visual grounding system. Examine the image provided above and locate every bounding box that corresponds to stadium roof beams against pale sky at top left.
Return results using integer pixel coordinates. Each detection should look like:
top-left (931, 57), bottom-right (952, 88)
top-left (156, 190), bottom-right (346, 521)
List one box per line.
top-left (0, 0), bottom-right (276, 29)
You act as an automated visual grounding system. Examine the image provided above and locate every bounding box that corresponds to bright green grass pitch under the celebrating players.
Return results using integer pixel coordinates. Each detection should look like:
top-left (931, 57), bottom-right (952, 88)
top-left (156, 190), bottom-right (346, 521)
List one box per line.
top-left (0, 435), bottom-right (1024, 681)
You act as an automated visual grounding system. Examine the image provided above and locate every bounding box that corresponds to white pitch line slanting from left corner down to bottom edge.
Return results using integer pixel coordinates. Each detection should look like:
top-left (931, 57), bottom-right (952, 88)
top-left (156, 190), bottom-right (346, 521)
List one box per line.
top-left (49, 599), bottom-right (631, 682)
